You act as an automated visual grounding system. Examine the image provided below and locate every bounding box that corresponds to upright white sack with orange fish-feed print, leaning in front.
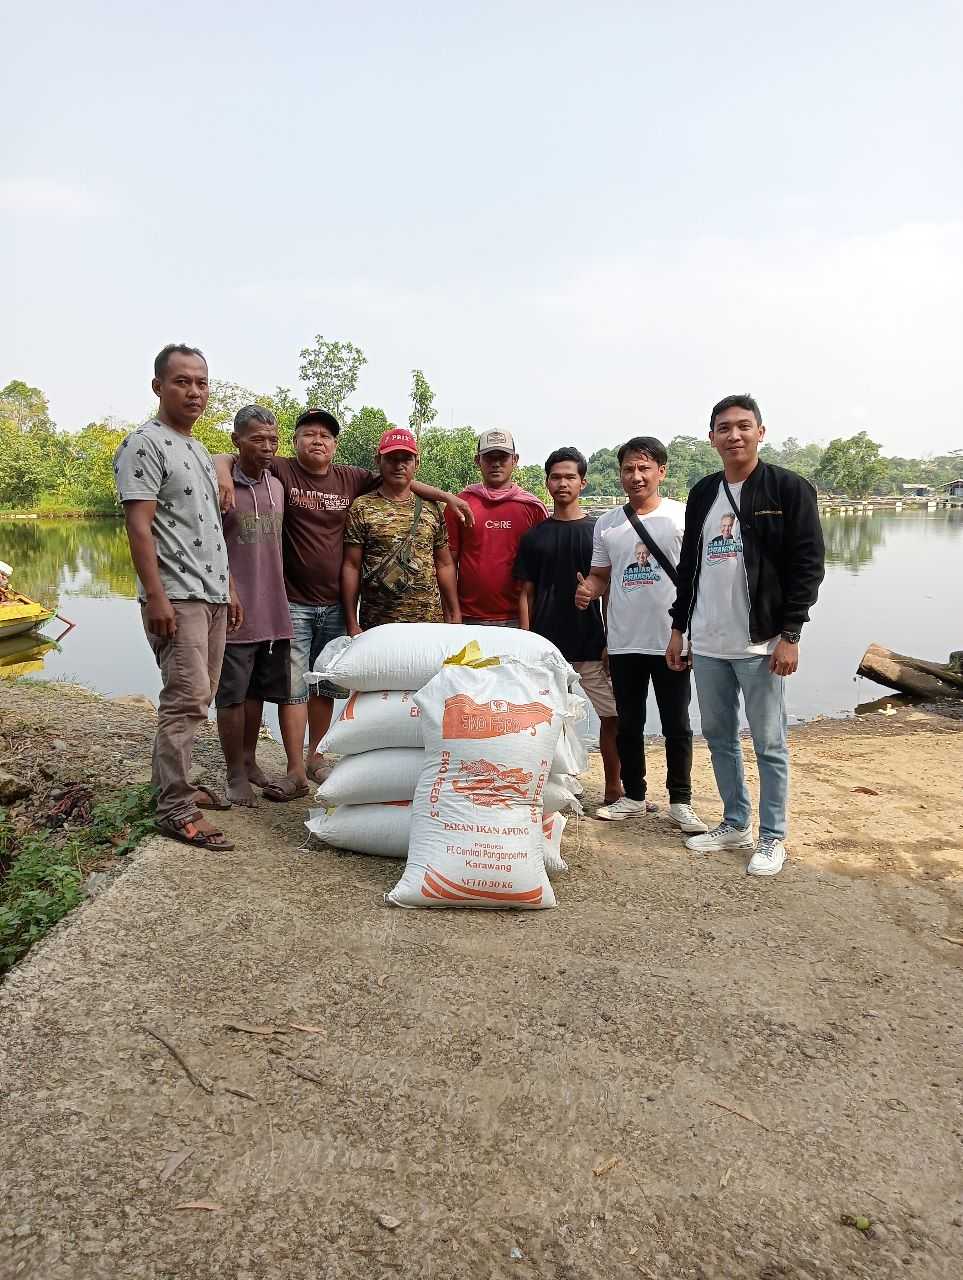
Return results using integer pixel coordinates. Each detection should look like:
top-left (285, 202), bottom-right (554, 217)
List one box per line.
top-left (385, 659), bottom-right (569, 910)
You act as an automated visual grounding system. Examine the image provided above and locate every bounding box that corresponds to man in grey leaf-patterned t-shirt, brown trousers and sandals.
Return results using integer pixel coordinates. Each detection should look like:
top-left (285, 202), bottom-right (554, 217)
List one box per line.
top-left (114, 343), bottom-right (243, 850)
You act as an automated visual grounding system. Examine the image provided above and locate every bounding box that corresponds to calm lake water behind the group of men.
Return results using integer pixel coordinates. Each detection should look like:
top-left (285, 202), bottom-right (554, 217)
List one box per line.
top-left (0, 509), bottom-right (963, 730)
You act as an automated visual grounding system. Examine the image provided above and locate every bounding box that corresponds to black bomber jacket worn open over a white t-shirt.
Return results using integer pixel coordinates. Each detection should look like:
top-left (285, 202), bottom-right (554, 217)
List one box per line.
top-left (668, 461), bottom-right (826, 644)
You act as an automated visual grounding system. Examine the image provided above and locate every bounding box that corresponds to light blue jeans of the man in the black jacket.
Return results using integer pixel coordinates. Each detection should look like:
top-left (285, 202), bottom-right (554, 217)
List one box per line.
top-left (693, 653), bottom-right (789, 840)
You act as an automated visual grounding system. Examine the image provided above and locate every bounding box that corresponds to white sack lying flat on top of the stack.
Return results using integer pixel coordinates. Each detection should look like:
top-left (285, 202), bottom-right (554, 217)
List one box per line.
top-left (305, 622), bottom-right (576, 692)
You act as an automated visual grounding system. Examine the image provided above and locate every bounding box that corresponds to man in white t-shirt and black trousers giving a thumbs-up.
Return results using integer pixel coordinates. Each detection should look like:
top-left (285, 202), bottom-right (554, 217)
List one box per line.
top-left (575, 435), bottom-right (706, 833)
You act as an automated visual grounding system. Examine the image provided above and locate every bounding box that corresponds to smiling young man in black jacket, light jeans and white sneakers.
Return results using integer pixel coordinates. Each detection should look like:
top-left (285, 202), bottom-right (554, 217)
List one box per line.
top-left (666, 396), bottom-right (825, 876)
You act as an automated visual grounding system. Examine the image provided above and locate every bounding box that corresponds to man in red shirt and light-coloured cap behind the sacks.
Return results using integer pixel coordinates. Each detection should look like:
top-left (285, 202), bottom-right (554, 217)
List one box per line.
top-left (444, 430), bottom-right (548, 627)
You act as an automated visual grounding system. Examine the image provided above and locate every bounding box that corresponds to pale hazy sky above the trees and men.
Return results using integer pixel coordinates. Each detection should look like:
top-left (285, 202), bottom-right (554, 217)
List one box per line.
top-left (0, 0), bottom-right (963, 461)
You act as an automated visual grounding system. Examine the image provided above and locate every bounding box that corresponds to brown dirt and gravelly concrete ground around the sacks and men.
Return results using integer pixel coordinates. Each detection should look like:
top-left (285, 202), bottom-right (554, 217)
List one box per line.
top-left (0, 685), bottom-right (963, 1280)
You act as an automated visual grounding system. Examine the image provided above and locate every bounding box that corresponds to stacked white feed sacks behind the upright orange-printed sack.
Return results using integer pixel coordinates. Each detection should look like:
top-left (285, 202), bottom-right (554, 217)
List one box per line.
top-left (307, 623), bottom-right (585, 867)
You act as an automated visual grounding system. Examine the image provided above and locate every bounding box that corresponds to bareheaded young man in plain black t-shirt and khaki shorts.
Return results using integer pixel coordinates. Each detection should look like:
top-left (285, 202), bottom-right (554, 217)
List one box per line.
top-left (515, 448), bottom-right (622, 805)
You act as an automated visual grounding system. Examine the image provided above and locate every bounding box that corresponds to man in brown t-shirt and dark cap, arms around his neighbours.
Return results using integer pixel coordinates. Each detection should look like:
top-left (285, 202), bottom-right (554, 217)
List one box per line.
top-left (216, 408), bottom-right (471, 800)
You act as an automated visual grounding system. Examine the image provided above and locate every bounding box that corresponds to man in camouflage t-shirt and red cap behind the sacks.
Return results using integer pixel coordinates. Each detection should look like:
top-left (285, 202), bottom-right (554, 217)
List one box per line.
top-left (341, 428), bottom-right (461, 636)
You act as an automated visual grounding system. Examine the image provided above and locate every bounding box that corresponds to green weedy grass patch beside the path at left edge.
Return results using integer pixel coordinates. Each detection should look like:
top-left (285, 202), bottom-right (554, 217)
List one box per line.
top-left (0, 785), bottom-right (155, 974)
